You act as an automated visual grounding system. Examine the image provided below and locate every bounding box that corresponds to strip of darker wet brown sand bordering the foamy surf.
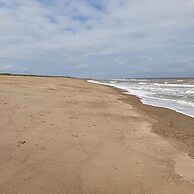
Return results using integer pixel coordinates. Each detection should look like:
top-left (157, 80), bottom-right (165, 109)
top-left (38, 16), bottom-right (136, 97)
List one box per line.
top-left (93, 83), bottom-right (194, 158)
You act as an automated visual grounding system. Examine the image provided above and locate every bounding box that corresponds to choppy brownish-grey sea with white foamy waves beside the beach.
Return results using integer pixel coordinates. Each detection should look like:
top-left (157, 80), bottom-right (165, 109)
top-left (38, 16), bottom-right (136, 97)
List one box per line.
top-left (88, 78), bottom-right (194, 118)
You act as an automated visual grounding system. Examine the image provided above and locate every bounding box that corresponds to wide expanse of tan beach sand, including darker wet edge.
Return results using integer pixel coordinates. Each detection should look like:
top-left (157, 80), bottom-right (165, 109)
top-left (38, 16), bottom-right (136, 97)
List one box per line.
top-left (0, 76), bottom-right (194, 194)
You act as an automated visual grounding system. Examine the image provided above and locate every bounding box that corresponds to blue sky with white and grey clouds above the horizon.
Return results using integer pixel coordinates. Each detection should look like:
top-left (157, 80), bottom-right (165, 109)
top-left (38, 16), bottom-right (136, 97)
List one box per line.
top-left (0, 0), bottom-right (194, 79)
